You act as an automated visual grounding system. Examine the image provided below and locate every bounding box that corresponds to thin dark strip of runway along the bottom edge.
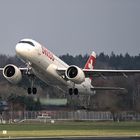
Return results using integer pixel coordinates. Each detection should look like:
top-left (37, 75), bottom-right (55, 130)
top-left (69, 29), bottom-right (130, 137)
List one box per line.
top-left (0, 136), bottom-right (140, 140)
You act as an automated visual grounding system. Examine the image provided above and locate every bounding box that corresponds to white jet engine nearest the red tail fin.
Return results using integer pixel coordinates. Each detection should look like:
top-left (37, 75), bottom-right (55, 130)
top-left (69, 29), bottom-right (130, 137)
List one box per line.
top-left (65, 65), bottom-right (85, 84)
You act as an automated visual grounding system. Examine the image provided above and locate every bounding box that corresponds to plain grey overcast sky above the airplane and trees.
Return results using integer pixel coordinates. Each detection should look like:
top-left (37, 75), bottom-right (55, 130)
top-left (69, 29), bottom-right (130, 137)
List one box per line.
top-left (0, 0), bottom-right (140, 55)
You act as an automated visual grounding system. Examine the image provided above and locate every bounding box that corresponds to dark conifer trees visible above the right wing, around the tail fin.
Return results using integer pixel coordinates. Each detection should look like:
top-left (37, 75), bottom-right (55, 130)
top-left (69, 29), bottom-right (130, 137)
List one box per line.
top-left (60, 52), bottom-right (140, 69)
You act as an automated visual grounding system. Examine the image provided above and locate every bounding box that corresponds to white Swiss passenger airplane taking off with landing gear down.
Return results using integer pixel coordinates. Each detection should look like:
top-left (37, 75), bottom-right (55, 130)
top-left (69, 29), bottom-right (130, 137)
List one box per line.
top-left (0, 39), bottom-right (140, 95)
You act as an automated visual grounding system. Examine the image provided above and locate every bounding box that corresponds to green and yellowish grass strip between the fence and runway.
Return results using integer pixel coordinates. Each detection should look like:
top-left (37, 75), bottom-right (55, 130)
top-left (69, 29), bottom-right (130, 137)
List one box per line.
top-left (0, 122), bottom-right (140, 138)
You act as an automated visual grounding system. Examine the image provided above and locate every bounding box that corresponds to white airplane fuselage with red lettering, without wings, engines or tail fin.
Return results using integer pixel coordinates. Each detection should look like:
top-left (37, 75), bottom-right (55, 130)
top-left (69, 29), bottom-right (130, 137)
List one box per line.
top-left (16, 40), bottom-right (90, 92)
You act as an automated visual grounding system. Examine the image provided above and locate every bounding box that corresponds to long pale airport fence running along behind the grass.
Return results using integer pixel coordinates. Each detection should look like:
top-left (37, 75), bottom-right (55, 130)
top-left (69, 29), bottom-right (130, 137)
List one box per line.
top-left (0, 110), bottom-right (140, 123)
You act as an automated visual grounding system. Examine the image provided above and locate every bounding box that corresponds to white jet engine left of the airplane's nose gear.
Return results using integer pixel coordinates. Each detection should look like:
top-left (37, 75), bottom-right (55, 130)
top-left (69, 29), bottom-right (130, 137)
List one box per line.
top-left (3, 64), bottom-right (22, 84)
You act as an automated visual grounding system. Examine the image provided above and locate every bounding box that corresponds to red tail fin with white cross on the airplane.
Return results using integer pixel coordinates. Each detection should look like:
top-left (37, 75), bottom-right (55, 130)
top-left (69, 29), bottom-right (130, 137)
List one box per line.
top-left (84, 52), bottom-right (96, 69)
